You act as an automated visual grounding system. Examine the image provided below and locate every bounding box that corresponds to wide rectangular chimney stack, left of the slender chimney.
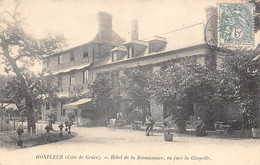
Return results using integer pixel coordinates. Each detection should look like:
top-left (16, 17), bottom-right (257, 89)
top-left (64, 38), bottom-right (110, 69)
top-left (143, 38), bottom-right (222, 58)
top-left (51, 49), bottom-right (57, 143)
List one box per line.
top-left (98, 12), bottom-right (113, 41)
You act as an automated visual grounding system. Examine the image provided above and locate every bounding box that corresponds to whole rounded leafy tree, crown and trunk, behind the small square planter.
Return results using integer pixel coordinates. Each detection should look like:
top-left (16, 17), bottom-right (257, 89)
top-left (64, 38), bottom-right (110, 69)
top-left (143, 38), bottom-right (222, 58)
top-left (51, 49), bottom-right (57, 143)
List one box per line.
top-left (150, 57), bottom-right (218, 130)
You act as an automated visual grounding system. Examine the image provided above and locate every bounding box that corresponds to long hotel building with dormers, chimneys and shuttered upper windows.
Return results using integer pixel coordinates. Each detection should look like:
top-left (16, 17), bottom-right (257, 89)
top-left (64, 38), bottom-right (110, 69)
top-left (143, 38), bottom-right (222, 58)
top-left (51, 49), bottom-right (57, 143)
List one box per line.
top-left (41, 8), bottom-right (216, 125)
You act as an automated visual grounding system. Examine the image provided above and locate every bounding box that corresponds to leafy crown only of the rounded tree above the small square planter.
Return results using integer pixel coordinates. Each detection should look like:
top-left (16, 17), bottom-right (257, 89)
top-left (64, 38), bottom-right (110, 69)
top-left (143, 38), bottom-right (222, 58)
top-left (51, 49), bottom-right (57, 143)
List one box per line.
top-left (150, 59), bottom-right (215, 105)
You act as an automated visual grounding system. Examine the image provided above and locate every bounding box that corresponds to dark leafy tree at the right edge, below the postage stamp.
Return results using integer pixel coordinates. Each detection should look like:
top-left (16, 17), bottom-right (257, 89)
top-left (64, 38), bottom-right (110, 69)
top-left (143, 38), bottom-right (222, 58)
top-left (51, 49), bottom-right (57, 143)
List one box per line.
top-left (216, 46), bottom-right (260, 127)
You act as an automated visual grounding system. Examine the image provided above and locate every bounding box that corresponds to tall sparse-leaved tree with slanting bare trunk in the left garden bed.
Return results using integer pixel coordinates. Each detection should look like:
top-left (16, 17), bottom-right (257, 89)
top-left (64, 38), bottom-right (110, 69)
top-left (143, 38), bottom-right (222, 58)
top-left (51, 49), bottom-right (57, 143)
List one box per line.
top-left (0, 0), bottom-right (66, 132)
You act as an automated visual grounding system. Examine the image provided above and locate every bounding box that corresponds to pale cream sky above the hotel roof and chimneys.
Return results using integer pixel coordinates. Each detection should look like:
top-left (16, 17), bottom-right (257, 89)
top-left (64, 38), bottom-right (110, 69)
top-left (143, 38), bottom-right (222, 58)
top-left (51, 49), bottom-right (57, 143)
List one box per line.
top-left (0, 0), bottom-right (254, 74)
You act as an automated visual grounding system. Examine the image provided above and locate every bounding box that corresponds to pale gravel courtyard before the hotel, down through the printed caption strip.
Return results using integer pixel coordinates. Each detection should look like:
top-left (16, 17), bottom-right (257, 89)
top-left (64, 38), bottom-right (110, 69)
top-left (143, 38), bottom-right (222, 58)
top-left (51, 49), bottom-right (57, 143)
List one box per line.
top-left (0, 126), bottom-right (260, 165)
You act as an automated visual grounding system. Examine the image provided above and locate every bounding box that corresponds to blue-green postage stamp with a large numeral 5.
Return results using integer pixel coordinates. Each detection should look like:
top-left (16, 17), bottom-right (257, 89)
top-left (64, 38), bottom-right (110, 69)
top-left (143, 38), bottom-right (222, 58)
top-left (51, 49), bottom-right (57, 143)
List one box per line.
top-left (218, 3), bottom-right (255, 47)
